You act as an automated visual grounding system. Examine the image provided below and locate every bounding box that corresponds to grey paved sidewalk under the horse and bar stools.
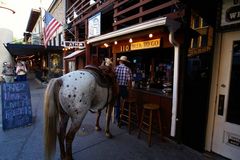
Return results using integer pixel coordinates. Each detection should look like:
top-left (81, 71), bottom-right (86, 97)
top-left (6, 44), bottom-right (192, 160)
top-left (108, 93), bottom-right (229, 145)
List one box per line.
top-left (0, 79), bottom-right (227, 160)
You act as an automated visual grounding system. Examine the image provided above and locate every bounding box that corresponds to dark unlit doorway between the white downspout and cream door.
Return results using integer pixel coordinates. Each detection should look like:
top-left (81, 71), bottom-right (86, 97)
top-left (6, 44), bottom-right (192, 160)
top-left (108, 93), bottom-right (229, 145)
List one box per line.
top-left (182, 52), bottom-right (212, 152)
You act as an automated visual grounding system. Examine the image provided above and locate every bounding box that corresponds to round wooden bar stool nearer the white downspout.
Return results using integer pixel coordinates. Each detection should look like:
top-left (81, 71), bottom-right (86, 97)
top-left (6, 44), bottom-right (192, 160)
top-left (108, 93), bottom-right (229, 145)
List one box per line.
top-left (138, 103), bottom-right (162, 147)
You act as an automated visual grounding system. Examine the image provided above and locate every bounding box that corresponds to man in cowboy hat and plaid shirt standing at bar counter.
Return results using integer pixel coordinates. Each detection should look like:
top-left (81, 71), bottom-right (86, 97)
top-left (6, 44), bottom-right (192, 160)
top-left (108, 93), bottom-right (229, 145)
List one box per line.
top-left (114, 56), bottom-right (132, 123)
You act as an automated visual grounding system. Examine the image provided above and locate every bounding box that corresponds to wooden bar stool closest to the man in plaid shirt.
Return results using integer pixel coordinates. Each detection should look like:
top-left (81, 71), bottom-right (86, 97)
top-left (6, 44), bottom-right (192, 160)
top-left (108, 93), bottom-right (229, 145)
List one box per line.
top-left (118, 97), bottom-right (138, 134)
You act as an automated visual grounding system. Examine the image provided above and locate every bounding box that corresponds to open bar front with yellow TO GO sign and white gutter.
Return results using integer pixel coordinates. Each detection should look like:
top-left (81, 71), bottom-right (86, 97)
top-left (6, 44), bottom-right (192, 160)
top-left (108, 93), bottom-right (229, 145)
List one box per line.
top-left (87, 17), bottom-right (180, 137)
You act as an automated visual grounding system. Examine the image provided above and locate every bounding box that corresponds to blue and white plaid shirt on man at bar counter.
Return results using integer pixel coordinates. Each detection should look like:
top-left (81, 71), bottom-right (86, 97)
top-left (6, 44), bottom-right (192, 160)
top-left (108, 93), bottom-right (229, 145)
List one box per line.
top-left (115, 64), bottom-right (132, 86)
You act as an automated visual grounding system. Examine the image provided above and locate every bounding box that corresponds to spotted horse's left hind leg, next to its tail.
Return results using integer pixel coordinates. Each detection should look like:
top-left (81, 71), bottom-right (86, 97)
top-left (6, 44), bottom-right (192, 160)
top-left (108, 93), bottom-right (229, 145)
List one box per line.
top-left (58, 111), bottom-right (69, 160)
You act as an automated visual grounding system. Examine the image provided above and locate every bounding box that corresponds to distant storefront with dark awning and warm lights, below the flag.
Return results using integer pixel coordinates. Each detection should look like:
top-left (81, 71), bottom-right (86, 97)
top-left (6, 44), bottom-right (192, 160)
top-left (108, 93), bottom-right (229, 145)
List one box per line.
top-left (5, 43), bottom-right (63, 82)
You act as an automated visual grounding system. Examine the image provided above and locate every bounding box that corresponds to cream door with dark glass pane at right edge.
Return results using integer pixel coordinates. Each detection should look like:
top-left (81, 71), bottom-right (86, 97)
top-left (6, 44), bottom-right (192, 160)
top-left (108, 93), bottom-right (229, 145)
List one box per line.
top-left (212, 31), bottom-right (240, 160)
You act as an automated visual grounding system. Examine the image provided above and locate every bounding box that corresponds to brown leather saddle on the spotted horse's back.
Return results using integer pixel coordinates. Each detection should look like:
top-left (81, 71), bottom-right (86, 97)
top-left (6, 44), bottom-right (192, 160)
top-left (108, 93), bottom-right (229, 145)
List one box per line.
top-left (84, 64), bottom-right (115, 88)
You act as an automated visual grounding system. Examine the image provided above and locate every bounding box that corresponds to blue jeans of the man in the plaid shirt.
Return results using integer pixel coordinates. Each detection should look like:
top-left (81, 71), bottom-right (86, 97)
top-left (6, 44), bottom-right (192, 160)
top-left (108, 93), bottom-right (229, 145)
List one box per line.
top-left (114, 86), bottom-right (128, 122)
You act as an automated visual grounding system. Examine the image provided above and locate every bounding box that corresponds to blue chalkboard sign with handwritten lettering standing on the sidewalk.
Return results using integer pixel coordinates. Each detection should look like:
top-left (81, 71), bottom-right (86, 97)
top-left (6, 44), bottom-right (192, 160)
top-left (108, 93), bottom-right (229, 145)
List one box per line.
top-left (1, 81), bottom-right (32, 130)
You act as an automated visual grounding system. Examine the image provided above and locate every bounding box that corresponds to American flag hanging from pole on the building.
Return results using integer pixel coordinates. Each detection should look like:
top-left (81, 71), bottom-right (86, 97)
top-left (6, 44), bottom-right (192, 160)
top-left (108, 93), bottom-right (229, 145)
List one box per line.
top-left (43, 11), bottom-right (62, 47)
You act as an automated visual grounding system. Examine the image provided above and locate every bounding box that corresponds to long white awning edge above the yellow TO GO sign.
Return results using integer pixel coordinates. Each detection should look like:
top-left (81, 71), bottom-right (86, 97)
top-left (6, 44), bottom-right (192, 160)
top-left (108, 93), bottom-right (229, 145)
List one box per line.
top-left (87, 17), bottom-right (180, 44)
